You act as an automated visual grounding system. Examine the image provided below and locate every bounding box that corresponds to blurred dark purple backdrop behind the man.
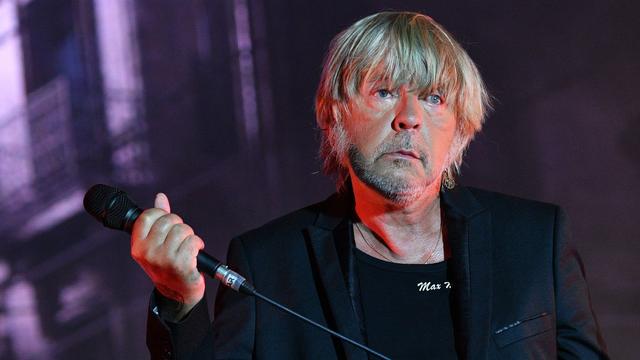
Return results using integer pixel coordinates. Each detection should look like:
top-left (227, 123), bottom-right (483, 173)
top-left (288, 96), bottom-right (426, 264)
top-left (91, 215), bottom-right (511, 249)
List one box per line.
top-left (0, 0), bottom-right (640, 360)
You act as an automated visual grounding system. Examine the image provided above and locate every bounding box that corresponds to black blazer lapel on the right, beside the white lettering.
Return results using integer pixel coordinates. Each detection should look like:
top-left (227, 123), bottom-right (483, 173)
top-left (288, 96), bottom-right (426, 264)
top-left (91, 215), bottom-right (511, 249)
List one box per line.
top-left (441, 186), bottom-right (492, 359)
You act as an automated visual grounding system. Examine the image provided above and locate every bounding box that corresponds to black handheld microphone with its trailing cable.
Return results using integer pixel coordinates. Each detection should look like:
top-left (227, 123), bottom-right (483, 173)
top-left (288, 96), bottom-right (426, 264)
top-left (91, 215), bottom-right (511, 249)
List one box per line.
top-left (83, 184), bottom-right (391, 360)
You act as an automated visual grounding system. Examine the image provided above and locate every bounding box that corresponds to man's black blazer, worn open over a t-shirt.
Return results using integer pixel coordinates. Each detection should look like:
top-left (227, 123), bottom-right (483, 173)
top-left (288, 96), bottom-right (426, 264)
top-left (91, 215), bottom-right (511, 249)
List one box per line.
top-left (147, 186), bottom-right (607, 360)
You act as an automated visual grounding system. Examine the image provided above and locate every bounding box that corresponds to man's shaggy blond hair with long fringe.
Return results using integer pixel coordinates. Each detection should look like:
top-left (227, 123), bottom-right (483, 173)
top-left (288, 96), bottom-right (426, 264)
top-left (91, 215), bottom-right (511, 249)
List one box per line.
top-left (316, 12), bottom-right (490, 188)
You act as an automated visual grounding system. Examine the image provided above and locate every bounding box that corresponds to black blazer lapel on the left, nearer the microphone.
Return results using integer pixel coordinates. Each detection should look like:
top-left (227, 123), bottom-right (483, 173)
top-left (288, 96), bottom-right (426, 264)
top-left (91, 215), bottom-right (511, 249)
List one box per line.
top-left (307, 194), bottom-right (368, 360)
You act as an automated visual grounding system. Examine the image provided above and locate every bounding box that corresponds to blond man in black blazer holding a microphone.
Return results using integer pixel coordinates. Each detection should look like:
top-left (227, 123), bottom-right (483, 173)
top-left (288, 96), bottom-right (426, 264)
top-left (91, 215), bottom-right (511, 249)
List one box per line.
top-left (131, 12), bottom-right (606, 359)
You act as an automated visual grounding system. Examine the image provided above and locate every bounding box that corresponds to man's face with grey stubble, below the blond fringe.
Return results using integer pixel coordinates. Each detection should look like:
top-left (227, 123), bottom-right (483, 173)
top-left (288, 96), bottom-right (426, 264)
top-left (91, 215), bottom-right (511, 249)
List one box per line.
top-left (343, 81), bottom-right (456, 204)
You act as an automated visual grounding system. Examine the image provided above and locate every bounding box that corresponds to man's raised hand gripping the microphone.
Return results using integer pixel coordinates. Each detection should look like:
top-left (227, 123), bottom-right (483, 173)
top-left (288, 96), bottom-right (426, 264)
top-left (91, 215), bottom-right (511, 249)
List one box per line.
top-left (131, 193), bottom-right (204, 319)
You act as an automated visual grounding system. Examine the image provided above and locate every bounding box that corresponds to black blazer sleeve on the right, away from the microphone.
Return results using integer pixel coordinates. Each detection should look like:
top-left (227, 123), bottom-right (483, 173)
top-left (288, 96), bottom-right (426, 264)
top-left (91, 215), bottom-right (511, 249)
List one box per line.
top-left (554, 208), bottom-right (608, 359)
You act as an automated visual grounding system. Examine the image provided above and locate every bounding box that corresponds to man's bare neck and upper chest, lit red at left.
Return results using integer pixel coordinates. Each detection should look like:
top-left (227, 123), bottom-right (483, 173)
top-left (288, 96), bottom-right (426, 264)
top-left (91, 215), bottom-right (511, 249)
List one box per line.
top-left (352, 177), bottom-right (444, 263)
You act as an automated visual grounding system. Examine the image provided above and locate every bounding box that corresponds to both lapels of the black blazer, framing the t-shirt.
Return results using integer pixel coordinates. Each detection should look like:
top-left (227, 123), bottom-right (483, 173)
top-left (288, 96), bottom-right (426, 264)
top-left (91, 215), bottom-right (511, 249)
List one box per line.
top-left (307, 186), bottom-right (492, 360)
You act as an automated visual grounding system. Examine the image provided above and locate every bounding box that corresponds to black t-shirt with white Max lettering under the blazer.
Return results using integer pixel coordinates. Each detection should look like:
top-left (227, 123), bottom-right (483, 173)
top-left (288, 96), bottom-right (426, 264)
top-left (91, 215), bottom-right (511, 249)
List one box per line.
top-left (356, 250), bottom-right (457, 360)
